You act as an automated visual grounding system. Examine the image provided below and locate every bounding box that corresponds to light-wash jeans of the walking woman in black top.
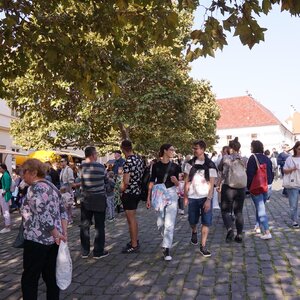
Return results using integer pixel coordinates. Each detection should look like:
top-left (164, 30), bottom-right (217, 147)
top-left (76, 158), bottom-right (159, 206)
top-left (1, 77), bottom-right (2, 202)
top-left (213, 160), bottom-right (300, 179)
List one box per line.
top-left (157, 187), bottom-right (178, 248)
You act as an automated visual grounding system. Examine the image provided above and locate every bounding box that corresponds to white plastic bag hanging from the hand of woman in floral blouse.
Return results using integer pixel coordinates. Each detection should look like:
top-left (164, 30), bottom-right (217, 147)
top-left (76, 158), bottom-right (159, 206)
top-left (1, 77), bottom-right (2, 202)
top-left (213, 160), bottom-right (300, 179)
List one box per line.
top-left (56, 241), bottom-right (72, 290)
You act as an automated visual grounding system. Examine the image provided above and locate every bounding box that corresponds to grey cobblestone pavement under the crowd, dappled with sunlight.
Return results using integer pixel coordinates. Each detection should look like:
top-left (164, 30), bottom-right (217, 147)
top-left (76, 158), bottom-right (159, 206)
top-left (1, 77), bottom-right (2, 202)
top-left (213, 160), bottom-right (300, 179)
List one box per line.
top-left (0, 182), bottom-right (300, 300)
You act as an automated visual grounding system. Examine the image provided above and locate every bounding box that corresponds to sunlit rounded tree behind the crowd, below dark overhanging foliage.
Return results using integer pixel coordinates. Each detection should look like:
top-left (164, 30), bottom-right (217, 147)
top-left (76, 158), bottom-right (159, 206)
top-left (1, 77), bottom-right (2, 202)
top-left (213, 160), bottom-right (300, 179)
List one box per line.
top-left (12, 48), bottom-right (219, 153)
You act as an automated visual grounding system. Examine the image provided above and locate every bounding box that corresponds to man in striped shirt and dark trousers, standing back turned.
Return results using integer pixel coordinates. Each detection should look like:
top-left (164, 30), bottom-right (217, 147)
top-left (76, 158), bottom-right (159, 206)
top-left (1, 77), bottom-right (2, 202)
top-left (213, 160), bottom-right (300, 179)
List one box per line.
top-left (80, 147), bottom-right (108, 259)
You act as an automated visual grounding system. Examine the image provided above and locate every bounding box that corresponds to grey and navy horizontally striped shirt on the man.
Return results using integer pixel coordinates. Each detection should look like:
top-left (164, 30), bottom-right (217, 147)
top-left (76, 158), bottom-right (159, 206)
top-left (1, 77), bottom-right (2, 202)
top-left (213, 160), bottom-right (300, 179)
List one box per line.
top-left (81, 162), bottom-right (107, 194)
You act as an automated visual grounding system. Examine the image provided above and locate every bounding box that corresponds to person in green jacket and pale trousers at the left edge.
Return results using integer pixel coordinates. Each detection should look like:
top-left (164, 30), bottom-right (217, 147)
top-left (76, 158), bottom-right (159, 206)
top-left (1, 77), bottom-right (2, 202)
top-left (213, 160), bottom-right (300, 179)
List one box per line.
top-left (0, 164), bottom-right (12, 233)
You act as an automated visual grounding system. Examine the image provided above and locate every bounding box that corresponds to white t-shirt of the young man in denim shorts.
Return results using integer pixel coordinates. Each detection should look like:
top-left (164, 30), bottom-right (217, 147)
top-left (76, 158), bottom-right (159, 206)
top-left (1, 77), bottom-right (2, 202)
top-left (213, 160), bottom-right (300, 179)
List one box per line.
top-left (184, 159), bottom-right (218, 199)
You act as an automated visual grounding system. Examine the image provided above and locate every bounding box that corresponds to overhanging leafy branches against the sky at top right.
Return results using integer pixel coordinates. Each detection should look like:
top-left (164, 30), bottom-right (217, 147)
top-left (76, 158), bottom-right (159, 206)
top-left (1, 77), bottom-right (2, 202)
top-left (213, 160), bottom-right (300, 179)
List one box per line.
top-left (187, 0), bottom-right (300, 60)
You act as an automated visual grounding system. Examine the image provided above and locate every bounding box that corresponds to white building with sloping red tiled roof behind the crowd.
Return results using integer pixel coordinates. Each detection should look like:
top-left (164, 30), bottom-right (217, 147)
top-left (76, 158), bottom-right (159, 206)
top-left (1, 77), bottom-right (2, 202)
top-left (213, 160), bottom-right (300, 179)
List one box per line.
top-left (214, 96), bottom-right (295, 156)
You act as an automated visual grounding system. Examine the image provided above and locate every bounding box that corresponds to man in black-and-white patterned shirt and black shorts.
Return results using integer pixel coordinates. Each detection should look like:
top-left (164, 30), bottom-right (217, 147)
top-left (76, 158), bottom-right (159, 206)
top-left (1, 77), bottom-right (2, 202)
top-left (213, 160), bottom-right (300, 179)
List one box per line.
top-left (121, 140), bottom-right (145, 253)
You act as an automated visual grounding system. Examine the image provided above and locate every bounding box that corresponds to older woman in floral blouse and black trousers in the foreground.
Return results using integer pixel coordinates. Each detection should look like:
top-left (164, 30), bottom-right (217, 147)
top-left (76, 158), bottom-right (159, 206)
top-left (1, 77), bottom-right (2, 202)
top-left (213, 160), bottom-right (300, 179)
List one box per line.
top-left (21, 159), bottom-right (68, 300)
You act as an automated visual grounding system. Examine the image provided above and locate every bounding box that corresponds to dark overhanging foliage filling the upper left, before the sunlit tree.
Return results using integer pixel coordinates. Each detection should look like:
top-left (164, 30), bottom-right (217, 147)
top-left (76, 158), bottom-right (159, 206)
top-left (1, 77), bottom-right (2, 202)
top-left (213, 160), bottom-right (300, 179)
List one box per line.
top-left (0, 0), bottom-right (190, 98)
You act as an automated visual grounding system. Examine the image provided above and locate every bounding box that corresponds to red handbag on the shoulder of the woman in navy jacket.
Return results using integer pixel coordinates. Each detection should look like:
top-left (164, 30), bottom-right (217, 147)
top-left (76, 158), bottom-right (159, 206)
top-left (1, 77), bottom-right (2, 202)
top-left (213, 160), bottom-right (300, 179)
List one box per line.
top-left (249, 154), bottom-right (268, 196)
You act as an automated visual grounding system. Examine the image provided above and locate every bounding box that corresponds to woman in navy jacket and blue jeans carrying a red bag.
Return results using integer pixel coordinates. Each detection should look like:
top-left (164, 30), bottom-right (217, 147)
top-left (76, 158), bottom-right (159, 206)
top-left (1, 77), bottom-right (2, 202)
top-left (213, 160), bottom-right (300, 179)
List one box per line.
top-left (247, 140), bottom-right (273, 240)
